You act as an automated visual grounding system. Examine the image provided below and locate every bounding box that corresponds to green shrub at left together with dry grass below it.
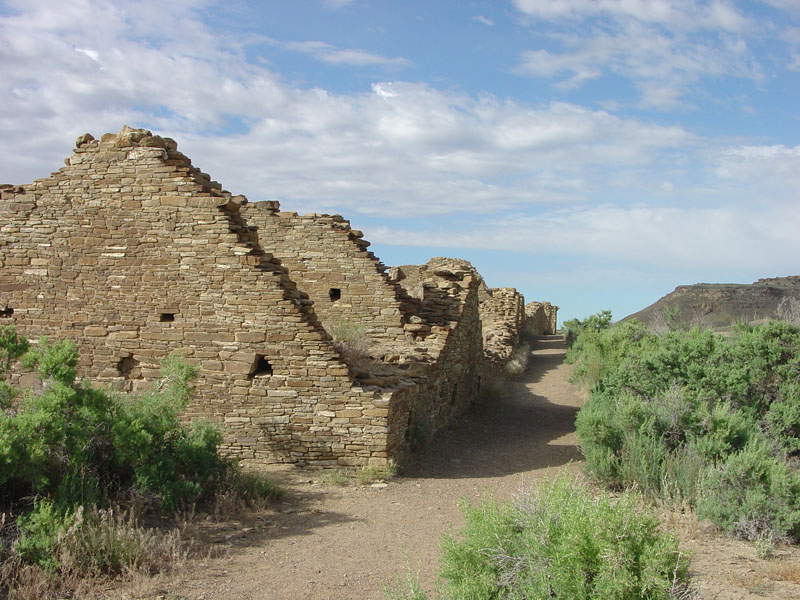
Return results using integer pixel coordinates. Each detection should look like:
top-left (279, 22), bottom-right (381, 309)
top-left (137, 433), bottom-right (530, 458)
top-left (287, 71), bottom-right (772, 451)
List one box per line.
top-left (0, 327), bottom-right (279, 592)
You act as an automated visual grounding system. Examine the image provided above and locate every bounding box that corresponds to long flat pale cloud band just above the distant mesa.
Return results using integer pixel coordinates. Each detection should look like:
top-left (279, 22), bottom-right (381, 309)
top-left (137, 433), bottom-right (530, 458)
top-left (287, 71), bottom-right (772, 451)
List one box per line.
top-left (367, 205), bottom-right (800, 272)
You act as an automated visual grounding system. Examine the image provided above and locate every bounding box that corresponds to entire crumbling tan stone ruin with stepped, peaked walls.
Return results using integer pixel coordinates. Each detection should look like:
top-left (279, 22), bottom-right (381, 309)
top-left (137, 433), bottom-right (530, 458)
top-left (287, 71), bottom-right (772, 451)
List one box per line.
top-left (0, 127), bottom-right (556, 467)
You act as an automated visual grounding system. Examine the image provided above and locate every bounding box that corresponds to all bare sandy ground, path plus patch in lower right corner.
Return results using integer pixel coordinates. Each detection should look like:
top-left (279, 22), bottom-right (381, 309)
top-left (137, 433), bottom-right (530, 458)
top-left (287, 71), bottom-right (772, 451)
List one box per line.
top-left (110, 336), bottom-right (800, 600)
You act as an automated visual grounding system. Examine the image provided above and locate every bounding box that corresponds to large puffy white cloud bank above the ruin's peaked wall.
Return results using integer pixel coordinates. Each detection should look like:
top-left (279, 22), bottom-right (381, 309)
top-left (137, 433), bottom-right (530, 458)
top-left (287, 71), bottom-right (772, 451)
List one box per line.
top-left (0, 2), bottom-right (694, 215)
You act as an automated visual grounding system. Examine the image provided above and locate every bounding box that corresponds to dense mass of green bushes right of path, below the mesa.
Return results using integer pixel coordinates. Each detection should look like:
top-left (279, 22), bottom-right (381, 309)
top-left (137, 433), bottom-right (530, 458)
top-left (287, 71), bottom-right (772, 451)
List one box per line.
top-left (570, 314), bottom-right (800, 541)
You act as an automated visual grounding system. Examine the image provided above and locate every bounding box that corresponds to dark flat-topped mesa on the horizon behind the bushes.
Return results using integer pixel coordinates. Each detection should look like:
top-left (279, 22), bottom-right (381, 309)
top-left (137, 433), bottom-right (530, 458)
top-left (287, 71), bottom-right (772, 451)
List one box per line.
top-left (622, 275), bottom-right (800, 329)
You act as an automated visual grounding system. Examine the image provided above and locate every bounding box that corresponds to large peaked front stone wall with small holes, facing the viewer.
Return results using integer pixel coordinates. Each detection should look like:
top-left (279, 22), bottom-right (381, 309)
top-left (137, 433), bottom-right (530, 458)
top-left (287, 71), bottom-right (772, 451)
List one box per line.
top-left (0, 128), bottom-right (399, 465)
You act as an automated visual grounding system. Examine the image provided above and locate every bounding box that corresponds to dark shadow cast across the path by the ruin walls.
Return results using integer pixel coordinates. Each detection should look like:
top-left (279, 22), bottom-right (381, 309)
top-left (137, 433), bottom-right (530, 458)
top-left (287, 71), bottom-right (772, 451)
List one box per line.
top-left (403, 336), bottom-right (582, 479)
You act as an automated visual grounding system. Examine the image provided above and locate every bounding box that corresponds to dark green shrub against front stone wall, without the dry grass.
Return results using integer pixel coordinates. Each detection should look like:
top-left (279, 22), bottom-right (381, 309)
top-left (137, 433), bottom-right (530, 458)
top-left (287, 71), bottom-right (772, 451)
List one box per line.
top-left (0, 339), bottom-right (229, 511)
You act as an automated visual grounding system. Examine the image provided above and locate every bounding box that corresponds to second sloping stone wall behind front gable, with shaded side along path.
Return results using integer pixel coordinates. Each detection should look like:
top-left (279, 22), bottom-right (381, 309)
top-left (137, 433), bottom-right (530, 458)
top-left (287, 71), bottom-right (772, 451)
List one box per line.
top-left (246, 209), bottom-right (482, 457)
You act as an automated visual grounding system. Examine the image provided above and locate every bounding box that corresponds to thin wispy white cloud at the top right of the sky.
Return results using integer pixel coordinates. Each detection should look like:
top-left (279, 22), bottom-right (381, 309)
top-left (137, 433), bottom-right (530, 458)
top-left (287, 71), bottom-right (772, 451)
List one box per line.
top-left (514, 0), bottom-right (780, 110)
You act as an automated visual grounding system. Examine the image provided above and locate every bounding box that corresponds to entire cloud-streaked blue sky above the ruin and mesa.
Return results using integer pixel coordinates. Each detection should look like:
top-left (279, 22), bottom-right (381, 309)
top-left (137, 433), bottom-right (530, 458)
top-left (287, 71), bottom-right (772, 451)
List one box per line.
top-left (0, 0), bottom-right (800, 319)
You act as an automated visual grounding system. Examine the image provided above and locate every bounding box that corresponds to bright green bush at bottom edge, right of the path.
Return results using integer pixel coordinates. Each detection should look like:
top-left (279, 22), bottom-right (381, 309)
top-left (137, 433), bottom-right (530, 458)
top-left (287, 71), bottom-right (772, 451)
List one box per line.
top-left (390, 476), bottom-right (691, 600)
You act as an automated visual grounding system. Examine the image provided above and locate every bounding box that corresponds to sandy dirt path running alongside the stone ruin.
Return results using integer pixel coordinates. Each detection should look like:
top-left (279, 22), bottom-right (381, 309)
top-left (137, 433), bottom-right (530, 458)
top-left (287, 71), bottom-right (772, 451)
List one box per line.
top-left (170, 336), bottom-right (581, 600)
